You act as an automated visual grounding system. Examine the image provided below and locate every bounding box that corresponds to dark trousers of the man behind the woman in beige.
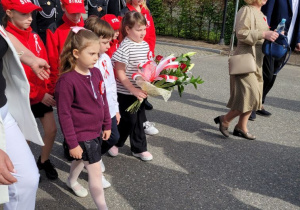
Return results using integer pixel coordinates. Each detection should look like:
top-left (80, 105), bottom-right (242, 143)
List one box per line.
top-left (262, 56), bottom-right (285, 103)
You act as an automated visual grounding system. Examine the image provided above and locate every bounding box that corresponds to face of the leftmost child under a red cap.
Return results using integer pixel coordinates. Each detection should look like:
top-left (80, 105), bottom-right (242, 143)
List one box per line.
top-left (6, 10), bottom-right (32, 30)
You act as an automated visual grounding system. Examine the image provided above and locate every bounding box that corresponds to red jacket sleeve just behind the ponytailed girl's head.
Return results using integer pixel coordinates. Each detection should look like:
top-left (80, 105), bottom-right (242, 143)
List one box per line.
top-left (46, 29), bottom-right (59, 94)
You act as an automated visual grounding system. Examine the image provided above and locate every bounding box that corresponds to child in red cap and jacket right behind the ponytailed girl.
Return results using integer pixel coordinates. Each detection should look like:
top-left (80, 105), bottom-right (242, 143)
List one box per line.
top-left (46, 0), bottom-right (85, 94)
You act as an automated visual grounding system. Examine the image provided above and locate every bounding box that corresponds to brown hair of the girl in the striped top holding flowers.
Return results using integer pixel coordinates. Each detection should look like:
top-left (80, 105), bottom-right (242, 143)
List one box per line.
top-left (121, 11), bottom-right (147, 38)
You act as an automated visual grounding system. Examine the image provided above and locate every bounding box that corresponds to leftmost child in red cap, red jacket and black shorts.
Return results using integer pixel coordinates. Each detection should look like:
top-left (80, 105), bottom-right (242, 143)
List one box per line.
top-left (1, 0), bottom-right (58, 180)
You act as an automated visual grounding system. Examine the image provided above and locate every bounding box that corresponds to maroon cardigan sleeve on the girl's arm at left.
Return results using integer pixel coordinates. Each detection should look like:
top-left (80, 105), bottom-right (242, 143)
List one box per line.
top-left (55, 78), bottom-right (78, 149)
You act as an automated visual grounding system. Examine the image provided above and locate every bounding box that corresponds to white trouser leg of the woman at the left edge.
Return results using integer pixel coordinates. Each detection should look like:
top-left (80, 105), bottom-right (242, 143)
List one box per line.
top-left (4, 114), bottom-right (40, 210)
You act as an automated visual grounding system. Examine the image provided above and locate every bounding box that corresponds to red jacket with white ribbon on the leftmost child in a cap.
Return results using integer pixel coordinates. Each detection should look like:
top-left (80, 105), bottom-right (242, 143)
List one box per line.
top-left (5, 21), bottom-right (49, 105)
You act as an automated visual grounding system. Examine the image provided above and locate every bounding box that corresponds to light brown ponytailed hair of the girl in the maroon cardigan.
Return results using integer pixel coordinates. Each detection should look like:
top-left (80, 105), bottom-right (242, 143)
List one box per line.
top-left (59, 29), bottom-right (99, 74)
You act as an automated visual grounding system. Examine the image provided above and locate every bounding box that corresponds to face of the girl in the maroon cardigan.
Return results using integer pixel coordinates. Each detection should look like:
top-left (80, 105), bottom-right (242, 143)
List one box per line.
top-left (73, 41), bottom-right (100, 69)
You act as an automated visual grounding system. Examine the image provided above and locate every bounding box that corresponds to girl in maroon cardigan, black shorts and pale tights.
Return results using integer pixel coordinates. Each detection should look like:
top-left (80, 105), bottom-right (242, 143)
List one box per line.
top-left (55, 27), bottom-right (111, 209)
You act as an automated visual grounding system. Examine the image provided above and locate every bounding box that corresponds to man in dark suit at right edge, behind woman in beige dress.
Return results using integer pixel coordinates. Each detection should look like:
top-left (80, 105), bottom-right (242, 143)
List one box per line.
top-left (249, 0), bottom-right (300, 120)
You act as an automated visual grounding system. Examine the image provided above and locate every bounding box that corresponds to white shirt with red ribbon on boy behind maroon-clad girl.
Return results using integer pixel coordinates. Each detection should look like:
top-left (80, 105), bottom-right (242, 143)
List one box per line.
top-left (95, 53), bottom-right (119, 118)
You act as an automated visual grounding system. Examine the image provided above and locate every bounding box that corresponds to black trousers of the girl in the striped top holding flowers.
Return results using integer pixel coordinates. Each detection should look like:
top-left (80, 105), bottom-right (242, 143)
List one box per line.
top-left (116, 93), bottom-right (147, 153)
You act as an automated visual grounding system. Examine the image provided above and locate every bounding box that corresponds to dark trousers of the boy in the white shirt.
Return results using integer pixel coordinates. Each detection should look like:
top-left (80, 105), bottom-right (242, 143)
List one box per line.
top-left (101, 116), bottom-right (120, 155)
